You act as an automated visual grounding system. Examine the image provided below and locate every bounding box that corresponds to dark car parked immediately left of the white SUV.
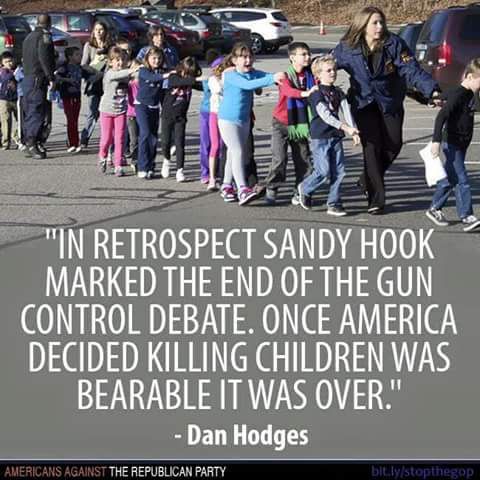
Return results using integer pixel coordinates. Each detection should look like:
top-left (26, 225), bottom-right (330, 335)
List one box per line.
top-left (147, 9), bottom-right (224, 53)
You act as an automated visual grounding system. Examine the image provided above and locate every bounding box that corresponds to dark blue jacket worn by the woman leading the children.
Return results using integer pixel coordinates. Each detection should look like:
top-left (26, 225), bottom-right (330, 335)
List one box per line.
top-left (333, 34), bottom-right (439, 114)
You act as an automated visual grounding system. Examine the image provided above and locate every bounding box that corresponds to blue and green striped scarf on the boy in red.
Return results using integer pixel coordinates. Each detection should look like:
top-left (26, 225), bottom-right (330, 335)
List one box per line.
top-left (287, 65), bottom-right (315, 140)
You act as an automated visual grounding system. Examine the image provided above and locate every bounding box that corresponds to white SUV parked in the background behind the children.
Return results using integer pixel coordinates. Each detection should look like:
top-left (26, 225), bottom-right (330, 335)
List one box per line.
top-left (210, 8), bottom-right (293, 53)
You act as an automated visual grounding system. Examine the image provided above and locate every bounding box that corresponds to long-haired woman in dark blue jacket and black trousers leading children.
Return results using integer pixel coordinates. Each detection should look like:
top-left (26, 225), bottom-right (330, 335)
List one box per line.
top-left (333, 6), bottom-right (440, 215)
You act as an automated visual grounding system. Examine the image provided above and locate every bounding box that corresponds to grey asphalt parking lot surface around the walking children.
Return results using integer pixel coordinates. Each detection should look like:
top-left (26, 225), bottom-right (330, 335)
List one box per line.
top-left (0, 27), bottom-right (480, 247)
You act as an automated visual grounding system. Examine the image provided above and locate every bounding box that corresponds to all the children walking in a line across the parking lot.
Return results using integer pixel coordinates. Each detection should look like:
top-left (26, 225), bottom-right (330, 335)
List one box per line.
top-left (5, 37), bottom-right (480, 231)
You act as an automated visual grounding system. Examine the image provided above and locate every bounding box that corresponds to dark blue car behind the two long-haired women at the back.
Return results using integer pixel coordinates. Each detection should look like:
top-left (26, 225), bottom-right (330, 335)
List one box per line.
top-left (92, 10), bottom-right (148, 54)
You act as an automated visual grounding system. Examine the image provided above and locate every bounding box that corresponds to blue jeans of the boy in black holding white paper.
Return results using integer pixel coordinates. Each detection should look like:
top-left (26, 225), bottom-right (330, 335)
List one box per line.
top-left (432, 143), bottom-right (473, 219)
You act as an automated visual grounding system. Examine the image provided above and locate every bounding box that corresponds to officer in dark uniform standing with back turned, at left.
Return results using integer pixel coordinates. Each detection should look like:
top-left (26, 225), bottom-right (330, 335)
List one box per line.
top-left (23, 14), bottom-right (55, 158)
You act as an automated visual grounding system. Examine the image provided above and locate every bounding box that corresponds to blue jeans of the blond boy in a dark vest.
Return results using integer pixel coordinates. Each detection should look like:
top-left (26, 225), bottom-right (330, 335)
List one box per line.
top-left (303, 137), bottom-right (345, 206)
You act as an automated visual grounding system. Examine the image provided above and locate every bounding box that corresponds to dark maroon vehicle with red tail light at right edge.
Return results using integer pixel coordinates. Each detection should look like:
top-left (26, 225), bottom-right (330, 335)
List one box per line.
top-left (416, 4), bottom-right (480, 89)
